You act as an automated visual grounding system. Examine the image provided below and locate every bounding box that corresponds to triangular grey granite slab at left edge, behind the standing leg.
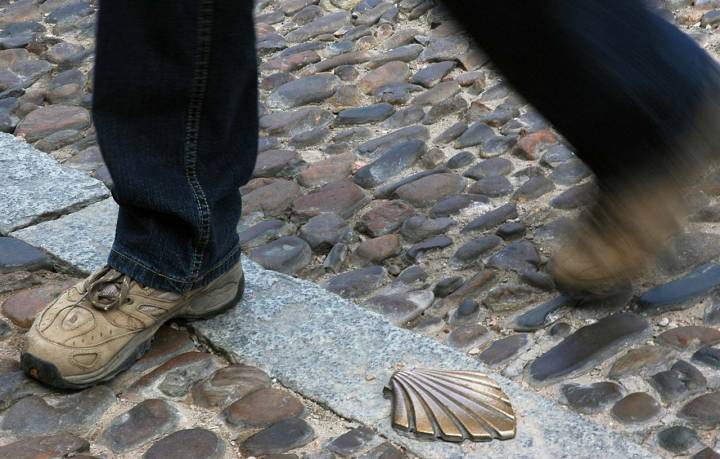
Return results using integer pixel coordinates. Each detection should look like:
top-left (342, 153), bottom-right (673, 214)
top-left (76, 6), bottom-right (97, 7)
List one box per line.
top-left (0, 133), bottom-right (109, 234)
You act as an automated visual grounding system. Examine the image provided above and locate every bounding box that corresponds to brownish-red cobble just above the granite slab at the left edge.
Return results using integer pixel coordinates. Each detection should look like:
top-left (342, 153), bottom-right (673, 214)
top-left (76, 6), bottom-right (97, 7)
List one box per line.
top-left (15, 105), bottom-right (90, 142)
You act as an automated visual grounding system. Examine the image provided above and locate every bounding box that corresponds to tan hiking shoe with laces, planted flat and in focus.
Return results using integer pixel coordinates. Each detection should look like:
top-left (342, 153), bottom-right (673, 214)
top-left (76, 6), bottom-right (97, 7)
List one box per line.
top-left (21, 262), bottom-right (245, 389)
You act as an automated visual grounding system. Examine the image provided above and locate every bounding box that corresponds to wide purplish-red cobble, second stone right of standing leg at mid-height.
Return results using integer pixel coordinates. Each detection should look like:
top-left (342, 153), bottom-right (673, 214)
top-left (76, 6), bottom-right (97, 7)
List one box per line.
top-left (293, 180), bottom-right (370, 218)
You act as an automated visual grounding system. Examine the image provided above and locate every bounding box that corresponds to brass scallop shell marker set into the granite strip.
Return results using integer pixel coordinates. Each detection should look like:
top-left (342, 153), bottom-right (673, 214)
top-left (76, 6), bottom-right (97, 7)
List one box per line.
top-left (390, 368), bottom-right (516, 442)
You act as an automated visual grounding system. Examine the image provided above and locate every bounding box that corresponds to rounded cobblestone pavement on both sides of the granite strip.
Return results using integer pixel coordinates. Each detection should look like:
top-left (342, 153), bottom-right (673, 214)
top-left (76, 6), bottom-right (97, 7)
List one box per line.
top-left (0, 0), bottom-right (720, 458)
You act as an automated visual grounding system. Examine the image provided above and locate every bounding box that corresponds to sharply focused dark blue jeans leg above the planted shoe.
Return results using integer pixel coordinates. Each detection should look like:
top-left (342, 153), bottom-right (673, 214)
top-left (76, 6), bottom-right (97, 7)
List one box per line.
top-left (93, 0), bottom-right (258, 292)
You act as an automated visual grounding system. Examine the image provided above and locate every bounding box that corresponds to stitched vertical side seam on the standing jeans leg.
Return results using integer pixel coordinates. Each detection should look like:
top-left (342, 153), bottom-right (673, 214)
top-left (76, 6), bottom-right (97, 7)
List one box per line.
top-left (185, 0), bottom-right (213, 278)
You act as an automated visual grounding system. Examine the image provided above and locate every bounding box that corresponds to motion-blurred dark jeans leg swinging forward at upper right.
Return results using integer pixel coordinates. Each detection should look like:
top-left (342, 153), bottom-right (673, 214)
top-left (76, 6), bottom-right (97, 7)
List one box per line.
top-left (444, 0), bottom-right (720, 188)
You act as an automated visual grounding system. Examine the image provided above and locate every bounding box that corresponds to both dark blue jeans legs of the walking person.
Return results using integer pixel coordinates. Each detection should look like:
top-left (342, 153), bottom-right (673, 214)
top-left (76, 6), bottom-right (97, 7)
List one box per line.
top-left (93, 0), bottom-right (717, 292)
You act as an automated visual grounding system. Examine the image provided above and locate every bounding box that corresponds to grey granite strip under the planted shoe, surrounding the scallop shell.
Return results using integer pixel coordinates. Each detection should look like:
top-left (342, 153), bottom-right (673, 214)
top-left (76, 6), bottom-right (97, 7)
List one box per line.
top-left (12, 192), bottom-right (654, 459)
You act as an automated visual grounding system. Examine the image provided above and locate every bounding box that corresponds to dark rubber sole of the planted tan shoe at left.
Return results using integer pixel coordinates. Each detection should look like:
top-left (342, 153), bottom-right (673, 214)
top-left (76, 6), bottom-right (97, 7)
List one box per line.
top-left (20, 275), bottom-right (245, 390)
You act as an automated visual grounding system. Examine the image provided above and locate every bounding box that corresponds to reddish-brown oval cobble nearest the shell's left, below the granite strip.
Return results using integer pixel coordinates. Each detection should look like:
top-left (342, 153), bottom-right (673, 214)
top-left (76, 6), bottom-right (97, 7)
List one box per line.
top-left (225, 388), bottom-right (305, 428)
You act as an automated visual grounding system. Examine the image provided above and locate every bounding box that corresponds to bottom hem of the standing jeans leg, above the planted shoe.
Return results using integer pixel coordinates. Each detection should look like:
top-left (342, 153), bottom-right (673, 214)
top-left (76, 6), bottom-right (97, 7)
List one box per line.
top-left (108, 244), bottom-right (240, 293)
